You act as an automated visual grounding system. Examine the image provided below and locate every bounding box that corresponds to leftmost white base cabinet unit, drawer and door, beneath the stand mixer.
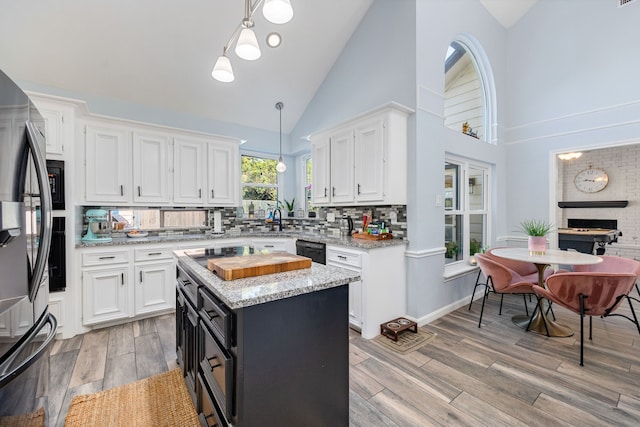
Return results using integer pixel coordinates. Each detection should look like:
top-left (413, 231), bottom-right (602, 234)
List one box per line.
top-left (82, 249), bottom-right (133, 325)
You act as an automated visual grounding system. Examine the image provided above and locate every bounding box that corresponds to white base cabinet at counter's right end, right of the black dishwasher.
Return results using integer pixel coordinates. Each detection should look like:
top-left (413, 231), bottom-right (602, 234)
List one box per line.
top-left (327, 245), bottom-right (406, 339)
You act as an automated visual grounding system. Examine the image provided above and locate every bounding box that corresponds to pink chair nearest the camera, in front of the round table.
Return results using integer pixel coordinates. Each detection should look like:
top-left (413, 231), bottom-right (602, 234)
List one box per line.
top-left (533, 272), bottom-right (638, 366)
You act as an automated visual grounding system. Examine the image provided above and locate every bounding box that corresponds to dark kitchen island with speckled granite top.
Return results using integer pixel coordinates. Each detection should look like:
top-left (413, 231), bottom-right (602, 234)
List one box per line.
top-left (174, 247), bottom-right (360, 426)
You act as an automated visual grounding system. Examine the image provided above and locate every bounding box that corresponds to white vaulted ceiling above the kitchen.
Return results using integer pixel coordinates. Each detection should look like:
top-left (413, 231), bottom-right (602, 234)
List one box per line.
top-left (0, 0), bottom-right (535, 132)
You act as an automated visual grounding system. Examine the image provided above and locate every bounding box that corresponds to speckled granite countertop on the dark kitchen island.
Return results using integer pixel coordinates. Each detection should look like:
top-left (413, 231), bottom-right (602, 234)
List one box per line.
top-left (173, 250), bottom-right (360, 309)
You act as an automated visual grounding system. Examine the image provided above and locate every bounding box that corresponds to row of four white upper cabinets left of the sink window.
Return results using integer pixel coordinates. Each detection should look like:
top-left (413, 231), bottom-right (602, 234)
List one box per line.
top-left (81, 120), bottom-right (240, 206)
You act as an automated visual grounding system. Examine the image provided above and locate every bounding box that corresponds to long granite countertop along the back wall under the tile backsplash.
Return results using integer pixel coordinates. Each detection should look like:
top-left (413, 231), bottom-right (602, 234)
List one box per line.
top-left (76, 231), bottom-right (407, 249)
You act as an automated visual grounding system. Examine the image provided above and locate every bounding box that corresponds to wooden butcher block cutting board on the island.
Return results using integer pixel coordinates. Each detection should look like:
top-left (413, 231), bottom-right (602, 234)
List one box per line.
top-left (207, 252), bottom-right (311, 280)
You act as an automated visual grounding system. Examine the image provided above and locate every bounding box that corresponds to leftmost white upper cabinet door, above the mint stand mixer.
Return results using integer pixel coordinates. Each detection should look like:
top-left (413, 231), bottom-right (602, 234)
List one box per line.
top-left (85, 126), bottom-right (131, 203)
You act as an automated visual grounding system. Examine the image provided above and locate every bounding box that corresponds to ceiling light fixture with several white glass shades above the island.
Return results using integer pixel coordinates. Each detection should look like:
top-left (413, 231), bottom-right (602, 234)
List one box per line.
top-left (211, 0), bottom-right (293, 83)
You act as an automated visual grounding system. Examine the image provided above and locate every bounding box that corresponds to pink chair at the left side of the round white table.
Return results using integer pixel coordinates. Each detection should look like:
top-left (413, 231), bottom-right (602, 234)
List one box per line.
top-left (474, 254), bottom-right (538, 328)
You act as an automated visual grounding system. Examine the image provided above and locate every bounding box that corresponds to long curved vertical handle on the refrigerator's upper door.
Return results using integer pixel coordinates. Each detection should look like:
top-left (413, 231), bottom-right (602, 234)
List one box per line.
top-left (26, 120), bottom-right (53, 301)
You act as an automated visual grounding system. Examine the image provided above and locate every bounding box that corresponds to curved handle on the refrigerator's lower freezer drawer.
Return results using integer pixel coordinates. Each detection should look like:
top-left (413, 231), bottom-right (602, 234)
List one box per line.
top-left (0, 312), bottom-right (58, 388)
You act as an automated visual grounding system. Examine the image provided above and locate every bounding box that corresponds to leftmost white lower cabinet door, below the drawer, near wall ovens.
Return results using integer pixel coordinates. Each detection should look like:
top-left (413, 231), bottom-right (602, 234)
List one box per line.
top-left (82, 267), bottom-right (131, 325)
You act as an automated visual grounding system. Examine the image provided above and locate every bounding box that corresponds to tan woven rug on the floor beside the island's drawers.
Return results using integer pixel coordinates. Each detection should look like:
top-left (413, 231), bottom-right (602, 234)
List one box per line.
top-left (64, 368), bottom-right (200, 427)
